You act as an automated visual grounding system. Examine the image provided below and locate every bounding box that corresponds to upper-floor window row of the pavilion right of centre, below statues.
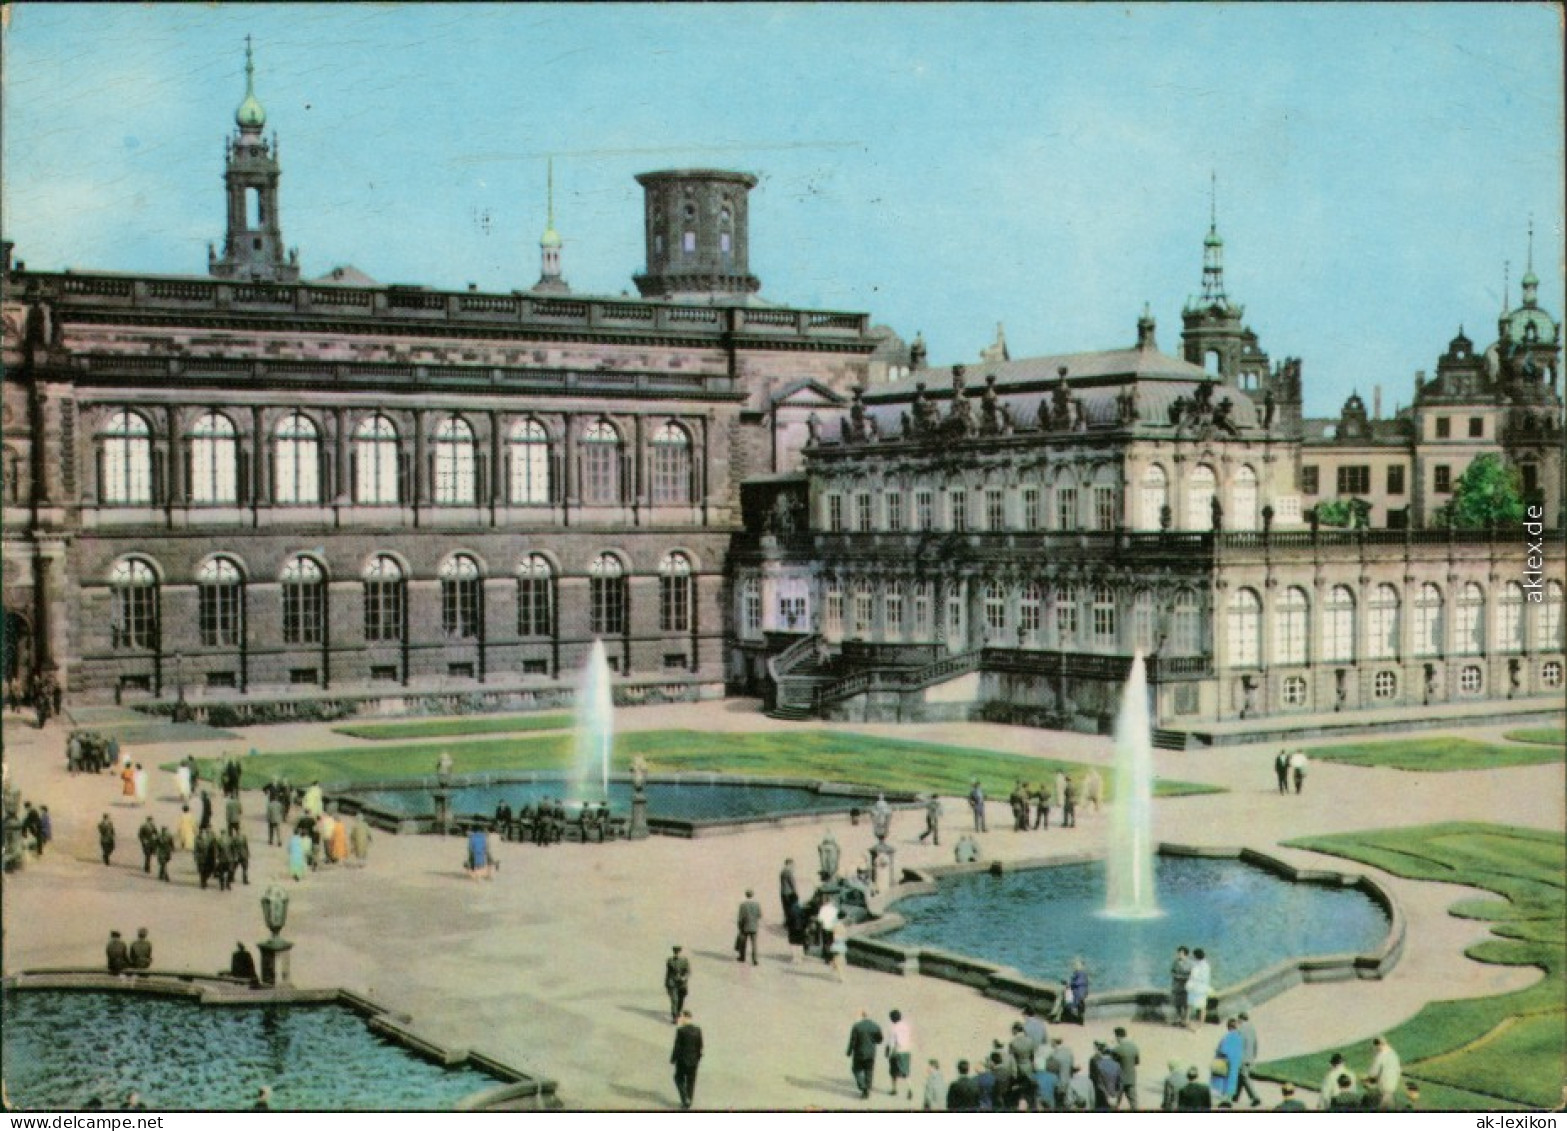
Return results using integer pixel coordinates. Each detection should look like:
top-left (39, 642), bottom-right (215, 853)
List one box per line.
top-left (824, 464), bottom-right (1260, 534)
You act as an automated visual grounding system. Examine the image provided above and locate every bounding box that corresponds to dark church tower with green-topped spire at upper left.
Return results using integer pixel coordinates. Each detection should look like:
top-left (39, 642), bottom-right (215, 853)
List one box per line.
top-left (207, 36), bottom-right (299, 282)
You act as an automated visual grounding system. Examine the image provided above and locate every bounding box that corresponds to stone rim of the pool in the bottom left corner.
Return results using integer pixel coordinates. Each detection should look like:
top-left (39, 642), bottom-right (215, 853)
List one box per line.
top-left (0, 967), bottom-right (561, 1111)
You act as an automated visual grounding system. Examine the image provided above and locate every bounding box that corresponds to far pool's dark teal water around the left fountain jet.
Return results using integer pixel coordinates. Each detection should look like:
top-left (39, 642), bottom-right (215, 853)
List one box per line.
top-left (323, 771), bottom-right (925, 840)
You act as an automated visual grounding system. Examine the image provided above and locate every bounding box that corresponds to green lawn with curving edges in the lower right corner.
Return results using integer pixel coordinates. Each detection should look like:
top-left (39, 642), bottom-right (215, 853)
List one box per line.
top-left (1257, 822), bottom-right (1567, 1111)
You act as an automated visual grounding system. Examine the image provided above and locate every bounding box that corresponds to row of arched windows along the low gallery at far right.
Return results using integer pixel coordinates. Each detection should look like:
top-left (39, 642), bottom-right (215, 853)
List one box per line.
top-left (1225, 581), bottom-right (1562, 667)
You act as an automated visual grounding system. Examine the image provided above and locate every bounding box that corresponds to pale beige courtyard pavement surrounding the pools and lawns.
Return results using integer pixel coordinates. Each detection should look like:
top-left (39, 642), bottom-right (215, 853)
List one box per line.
top-left (3, 700), bottom-right (1567, 1111)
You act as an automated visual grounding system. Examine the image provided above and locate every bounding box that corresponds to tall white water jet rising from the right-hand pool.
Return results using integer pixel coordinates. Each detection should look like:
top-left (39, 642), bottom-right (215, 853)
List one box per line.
top-left (1105, 652), bottom-right (1160, 920)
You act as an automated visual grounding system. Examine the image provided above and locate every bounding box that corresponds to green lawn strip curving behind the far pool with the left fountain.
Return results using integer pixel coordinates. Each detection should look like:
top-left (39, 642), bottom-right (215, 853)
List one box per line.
top-left (171, 730), bottom-right (1219, 800)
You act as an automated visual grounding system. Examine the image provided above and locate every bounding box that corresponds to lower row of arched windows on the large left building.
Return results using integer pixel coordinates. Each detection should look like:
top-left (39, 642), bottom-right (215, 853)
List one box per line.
top-left (110, 553), bottom-right (693, 650)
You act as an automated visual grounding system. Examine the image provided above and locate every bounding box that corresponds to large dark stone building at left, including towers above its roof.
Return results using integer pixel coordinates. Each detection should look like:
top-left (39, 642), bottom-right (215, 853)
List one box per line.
top-left (0, 50), bottom-right (878, 714)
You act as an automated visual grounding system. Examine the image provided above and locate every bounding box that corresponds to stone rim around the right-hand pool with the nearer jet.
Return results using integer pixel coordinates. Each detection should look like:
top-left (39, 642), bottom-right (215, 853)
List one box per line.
top-left (848, 844), bottom-right (1406, 1020)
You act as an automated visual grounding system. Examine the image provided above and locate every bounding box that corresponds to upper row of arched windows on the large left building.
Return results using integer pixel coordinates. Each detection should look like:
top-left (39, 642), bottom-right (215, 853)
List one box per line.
top-left (99, 410), bottom-right (696, 506)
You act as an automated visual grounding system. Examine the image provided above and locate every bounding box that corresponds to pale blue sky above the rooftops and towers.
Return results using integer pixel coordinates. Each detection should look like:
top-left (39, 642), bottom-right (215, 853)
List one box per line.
top-left (3, 3), bottom-right (1564, 414)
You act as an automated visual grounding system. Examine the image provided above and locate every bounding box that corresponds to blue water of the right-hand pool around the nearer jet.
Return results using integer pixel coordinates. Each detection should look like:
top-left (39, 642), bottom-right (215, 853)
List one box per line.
top-left (881, 855), bottom-right (1390, 990)
